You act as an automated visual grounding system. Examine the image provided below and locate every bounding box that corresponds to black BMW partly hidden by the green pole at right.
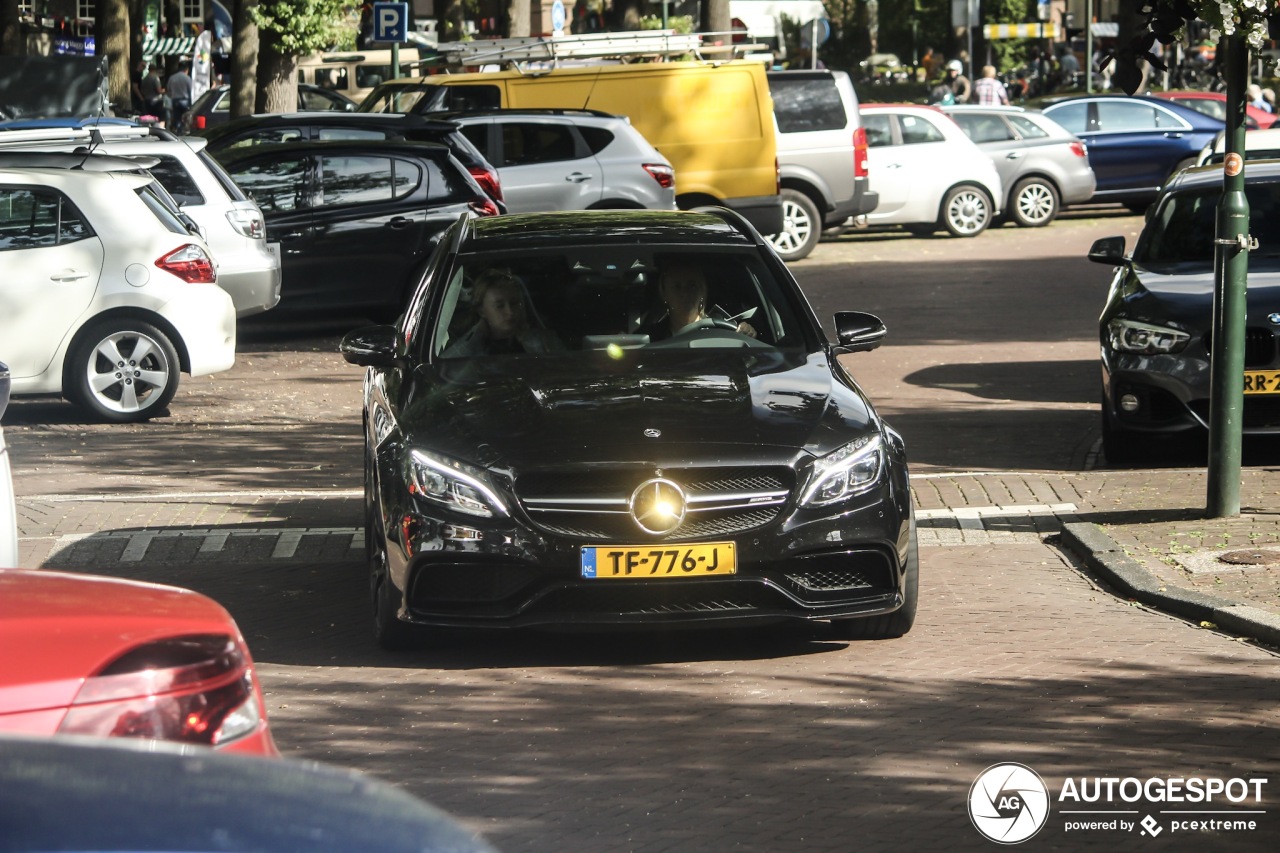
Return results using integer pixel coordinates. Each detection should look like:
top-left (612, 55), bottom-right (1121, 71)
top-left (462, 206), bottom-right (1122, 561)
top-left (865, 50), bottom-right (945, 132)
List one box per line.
top-left (1089, 160), bottom-right (1280, 464)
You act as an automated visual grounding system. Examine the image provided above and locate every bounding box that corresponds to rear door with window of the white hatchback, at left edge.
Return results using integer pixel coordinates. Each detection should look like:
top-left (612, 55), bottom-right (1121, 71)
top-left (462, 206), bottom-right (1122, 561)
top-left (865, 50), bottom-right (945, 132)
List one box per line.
top-left (0, 184), bottom-right (102, 380)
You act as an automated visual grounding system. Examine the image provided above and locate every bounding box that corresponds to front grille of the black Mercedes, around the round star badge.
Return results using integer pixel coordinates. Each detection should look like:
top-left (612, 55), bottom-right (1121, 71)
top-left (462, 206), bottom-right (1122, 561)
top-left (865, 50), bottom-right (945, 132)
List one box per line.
top-left (515, 466), bottom-right (795, 542)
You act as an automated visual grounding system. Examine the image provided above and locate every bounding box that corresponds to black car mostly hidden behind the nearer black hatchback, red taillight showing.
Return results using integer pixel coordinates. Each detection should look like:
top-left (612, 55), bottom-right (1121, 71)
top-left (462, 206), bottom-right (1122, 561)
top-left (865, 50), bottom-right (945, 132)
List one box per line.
top-left (194, 111), bottom-right (507, 213)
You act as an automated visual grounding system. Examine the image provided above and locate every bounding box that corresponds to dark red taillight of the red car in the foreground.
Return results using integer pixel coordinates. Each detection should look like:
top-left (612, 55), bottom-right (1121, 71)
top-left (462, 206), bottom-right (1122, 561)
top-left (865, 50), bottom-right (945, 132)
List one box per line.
top-left (58, 635), bottom-right (262, 747)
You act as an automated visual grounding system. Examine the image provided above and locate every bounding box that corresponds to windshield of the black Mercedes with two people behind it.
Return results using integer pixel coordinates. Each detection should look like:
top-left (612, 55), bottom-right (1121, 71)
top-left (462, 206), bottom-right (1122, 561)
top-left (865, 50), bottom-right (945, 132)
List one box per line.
top-left (429, 246), bottom-right (814, 359)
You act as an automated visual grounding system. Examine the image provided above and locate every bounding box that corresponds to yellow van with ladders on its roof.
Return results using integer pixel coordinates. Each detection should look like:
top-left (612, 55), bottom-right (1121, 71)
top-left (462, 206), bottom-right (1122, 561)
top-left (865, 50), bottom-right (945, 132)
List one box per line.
top-left (360, 60), bottom-right (782, 234)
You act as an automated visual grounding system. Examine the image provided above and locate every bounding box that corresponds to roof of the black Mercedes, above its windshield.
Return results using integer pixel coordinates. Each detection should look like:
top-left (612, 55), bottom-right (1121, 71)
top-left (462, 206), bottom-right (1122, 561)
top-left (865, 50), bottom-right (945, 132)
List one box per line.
top-left (465, 210), bottom-right (758, 251)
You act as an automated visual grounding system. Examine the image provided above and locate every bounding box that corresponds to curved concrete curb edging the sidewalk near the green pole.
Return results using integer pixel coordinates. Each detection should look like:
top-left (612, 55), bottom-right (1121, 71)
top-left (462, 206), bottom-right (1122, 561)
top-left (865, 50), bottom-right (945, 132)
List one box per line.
top-left (1062, 521), bottom-right (1280, 646)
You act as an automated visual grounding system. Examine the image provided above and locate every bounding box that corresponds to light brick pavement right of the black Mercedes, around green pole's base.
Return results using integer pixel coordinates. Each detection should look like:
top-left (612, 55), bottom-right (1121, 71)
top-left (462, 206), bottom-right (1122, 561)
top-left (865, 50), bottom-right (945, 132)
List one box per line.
top-left (911, 467), bottom-right (1280, 646)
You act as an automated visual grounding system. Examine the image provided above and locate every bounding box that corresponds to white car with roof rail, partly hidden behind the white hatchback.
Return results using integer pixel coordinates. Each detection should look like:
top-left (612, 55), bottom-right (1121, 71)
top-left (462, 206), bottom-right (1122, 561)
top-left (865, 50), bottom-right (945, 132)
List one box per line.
top-left (0, 120), bottom-right (280, 318)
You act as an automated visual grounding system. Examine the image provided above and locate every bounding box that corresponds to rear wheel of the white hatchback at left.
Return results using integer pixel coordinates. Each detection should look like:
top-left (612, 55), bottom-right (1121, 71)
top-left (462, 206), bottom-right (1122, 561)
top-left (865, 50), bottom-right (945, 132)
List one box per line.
top-left (63, 318), bottom-right (182, 424)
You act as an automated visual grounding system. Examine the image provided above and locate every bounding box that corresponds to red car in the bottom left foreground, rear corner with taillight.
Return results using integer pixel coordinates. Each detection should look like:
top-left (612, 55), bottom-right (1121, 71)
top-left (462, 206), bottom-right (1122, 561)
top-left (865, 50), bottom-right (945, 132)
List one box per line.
top-left (0, 569), bottom-right (279, 756)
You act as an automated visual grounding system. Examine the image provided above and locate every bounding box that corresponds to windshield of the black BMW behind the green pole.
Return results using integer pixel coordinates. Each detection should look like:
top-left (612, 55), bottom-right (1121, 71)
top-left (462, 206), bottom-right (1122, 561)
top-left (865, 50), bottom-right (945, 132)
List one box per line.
top-left (1134, 181), bottom-right (1280, 269)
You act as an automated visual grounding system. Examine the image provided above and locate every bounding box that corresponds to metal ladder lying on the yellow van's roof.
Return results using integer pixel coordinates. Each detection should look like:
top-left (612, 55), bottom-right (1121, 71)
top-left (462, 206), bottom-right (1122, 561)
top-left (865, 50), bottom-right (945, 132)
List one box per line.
top-left (424, 29), bottom-right (763, 67)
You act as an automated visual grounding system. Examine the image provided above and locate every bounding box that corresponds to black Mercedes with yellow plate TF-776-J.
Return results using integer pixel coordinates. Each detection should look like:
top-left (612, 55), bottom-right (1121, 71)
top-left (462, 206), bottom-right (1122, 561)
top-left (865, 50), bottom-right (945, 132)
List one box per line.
top-left (342, 209), bottom-right (919, 648)
